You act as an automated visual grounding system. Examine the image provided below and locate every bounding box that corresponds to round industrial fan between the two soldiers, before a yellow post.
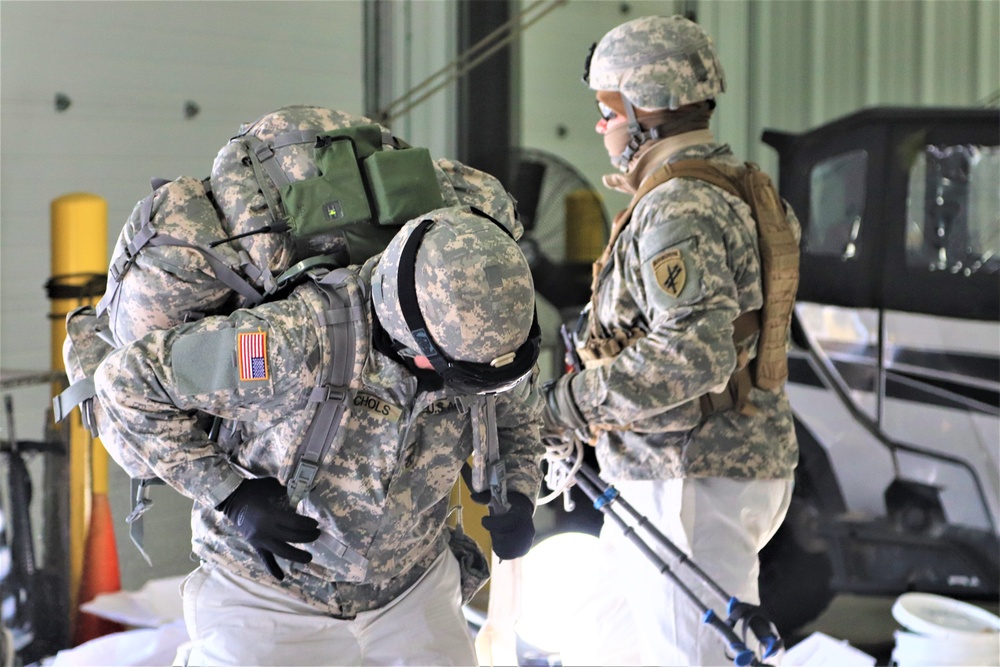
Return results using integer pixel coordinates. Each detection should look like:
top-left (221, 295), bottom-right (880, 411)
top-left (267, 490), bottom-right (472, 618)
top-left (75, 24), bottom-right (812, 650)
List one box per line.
top-left (511, 148), bottom-right (609, 310)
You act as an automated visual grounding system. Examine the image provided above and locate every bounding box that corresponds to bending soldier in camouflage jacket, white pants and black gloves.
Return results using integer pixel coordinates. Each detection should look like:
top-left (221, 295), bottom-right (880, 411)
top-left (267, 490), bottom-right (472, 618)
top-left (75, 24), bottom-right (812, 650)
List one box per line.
top-left (95, 207), bottom-right (541, 665)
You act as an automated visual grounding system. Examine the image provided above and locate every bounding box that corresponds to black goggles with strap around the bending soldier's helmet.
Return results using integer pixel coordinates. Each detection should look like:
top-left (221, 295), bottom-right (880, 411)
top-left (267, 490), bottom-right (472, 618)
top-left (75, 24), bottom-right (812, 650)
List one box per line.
top-left (396, 208), bottom-right (542, 394)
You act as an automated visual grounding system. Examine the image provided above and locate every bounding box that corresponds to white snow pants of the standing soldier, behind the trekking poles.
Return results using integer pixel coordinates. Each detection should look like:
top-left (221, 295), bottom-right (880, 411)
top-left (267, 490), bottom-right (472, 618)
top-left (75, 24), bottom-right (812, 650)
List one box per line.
top-left (562, 478), bottom-right (793, 666)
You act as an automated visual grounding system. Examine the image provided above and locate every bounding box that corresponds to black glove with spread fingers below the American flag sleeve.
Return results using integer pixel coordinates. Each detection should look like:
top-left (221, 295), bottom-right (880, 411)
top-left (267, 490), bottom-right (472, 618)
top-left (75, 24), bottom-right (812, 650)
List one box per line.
top-left (215, 477), bottom-right (320, 581)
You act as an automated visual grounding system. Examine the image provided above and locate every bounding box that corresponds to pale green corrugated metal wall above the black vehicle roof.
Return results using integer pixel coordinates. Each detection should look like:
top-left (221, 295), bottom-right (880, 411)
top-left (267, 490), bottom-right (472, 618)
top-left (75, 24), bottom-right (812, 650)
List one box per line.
top-left (708, 0), bottom-right (1000, 171)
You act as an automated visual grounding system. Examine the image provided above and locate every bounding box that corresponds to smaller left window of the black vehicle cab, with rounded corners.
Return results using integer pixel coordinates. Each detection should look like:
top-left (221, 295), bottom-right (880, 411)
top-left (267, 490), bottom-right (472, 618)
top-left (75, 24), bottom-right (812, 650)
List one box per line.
top-left (803, 150), bottom-right (868, 260)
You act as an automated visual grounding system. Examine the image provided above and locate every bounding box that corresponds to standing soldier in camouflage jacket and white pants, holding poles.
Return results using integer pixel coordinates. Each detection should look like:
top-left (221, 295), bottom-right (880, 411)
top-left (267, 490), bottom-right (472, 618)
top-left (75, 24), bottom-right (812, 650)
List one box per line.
top-left (544, 16), bottom-right (798, 665)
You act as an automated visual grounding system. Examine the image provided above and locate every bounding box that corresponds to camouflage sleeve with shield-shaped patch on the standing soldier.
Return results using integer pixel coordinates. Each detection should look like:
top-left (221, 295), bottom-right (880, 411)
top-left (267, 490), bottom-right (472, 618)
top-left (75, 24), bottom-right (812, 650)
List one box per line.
top-left (572, 179), bottom-right (739, 431)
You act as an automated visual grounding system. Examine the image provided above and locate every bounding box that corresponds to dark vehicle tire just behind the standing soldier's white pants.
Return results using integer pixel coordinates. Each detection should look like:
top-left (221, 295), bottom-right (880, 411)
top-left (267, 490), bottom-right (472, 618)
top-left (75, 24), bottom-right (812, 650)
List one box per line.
top-left (758, 498), bottom-right (834, 644)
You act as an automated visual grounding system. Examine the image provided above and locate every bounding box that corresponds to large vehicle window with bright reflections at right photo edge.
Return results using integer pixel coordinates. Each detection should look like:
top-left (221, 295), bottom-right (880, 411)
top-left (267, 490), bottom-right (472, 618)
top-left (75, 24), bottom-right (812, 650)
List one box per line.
top-left (906, 145), bottom-right (1000, 276)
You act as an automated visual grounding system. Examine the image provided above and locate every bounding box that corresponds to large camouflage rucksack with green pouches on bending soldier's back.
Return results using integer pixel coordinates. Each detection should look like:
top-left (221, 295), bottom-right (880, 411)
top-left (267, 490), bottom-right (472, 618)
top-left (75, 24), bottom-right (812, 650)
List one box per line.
top-left (53, 106), bottom-right (523, 560)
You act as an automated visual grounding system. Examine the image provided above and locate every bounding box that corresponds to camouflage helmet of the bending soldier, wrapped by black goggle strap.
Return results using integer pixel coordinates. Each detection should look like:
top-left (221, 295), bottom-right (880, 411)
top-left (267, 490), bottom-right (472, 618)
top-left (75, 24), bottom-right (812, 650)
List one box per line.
top-left (372, 207), bottom-right (535, 367)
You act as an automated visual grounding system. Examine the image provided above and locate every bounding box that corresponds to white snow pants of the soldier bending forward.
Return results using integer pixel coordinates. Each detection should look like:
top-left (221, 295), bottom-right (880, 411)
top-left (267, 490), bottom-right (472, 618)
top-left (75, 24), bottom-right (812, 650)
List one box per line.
top-left (175, 551), bottom-right (476, 666)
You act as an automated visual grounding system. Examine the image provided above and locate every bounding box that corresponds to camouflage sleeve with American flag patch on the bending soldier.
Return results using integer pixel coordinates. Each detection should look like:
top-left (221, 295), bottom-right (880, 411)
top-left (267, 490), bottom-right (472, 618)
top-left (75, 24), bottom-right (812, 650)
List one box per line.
top-left (95, 292), bottom-right (318, 507)
